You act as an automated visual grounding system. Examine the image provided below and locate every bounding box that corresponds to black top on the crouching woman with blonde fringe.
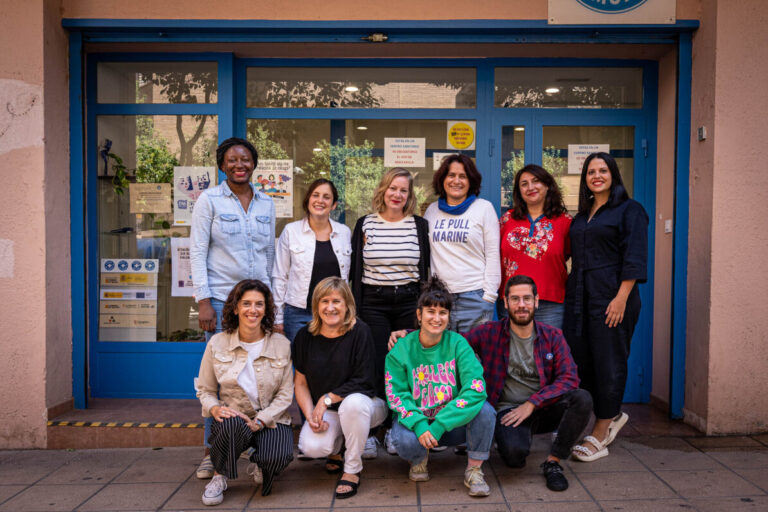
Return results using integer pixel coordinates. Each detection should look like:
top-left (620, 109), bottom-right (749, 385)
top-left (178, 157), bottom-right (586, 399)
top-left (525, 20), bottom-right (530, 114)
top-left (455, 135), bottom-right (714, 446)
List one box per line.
top-left (293, 318), bottom-right (375, 408)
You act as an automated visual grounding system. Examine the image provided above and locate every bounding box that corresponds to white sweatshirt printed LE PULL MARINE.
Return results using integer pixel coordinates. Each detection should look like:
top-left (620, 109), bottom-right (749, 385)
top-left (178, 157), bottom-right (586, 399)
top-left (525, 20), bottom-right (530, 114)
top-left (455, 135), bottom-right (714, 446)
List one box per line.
top-left (424, 198), bottom-right (501, 302)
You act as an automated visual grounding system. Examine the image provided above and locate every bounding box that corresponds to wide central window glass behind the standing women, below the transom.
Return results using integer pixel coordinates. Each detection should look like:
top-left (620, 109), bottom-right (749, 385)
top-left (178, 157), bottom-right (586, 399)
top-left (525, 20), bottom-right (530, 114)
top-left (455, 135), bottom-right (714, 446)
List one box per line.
top-left (247, 119), bottom-right (475, 231)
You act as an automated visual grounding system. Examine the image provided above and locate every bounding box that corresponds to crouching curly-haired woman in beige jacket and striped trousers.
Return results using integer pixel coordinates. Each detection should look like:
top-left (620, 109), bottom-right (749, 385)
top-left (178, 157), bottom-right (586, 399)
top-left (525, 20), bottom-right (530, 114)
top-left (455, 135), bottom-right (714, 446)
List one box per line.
top-left (197, 279), bottom-right (293, 505)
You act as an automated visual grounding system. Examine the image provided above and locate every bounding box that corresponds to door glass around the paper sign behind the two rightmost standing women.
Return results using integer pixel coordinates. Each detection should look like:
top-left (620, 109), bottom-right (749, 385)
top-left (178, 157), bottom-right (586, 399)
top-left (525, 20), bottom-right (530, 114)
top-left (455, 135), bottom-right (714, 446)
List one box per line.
top-left (542, 126), bottom-right (635, 215)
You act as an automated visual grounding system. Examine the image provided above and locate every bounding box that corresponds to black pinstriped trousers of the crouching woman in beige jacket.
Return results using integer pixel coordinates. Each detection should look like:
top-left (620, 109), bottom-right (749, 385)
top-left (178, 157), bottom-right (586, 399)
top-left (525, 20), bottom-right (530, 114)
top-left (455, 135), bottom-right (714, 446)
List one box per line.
top-left (208, 418), bottom-right (293, 496)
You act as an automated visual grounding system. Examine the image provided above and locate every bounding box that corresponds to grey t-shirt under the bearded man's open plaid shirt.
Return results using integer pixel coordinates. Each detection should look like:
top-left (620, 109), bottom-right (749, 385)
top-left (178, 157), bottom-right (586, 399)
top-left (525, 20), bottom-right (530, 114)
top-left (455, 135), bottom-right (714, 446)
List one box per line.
top-left (496, 329), bottom-right (541, 411)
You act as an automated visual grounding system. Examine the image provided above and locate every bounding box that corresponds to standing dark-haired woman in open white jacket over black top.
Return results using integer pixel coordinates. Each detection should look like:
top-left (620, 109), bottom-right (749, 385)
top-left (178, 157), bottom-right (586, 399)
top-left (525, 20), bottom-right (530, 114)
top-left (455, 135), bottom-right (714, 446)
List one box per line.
top-left (272, 178), bottom-right (352, 343)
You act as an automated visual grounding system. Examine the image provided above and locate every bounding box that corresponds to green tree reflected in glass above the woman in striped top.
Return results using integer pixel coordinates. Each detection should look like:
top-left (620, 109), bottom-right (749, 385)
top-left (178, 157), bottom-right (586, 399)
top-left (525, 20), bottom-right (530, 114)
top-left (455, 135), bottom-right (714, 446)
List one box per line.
top-left (304, 137), bottom-right (427, 222)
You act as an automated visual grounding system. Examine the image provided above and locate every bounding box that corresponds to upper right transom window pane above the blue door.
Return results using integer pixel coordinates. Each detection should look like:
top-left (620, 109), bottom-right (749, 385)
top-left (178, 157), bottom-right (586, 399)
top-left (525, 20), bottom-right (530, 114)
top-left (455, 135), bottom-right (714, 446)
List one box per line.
top-left (494, 68), bottom-right (643, 108)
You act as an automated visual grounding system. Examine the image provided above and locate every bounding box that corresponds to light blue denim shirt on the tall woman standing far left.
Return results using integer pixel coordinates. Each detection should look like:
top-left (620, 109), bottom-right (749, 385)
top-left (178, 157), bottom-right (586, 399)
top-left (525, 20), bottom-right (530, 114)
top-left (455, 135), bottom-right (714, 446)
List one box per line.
top-left (189, 181), bottom-right (275, 302)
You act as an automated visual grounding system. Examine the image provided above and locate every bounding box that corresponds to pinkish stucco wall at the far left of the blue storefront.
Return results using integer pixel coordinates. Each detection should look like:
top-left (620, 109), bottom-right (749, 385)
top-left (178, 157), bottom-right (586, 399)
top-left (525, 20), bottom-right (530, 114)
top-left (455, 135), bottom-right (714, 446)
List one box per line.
top-left (0, 0), bottom-right (72, 448)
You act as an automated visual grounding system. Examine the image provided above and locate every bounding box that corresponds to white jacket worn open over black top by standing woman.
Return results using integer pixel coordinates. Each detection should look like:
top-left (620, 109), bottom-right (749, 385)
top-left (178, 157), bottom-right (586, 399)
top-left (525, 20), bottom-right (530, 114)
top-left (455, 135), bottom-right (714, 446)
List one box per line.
top-left (272, 217), bottom-right (352, 324)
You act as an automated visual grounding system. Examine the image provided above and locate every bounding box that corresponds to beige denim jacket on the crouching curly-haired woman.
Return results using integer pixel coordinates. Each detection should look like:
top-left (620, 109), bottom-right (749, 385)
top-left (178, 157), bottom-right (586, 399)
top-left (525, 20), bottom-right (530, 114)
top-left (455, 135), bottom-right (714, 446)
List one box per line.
top-left (196, 330), bottom-right (293, 428)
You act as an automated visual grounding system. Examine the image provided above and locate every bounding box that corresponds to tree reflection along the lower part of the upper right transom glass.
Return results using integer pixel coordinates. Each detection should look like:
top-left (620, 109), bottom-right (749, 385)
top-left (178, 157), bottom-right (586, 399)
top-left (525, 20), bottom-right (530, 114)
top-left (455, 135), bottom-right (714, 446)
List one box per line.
top-left (495, 84), bottom-right (626, 108)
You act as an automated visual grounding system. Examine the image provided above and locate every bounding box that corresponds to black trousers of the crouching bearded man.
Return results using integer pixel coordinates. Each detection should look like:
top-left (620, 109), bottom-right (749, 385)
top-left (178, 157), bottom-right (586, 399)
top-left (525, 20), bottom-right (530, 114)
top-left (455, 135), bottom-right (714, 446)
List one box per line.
top-left (495, 389), bottom-right (592, 468)
